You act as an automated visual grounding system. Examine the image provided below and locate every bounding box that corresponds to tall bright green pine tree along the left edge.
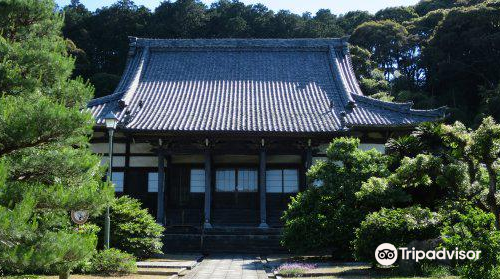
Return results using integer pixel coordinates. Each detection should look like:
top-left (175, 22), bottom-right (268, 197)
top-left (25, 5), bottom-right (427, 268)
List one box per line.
top-left (0, 0), bottom-right (113, 277)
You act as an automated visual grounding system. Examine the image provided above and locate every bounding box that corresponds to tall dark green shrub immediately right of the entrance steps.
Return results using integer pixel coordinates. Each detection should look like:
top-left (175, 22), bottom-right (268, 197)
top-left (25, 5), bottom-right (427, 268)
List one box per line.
top-left (282, 138), bottom-right (389, 259)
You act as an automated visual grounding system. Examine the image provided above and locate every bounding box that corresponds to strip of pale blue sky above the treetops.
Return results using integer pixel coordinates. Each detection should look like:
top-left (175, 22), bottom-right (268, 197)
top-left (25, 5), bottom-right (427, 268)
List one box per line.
top-left (56, 0), bottom-right (418, 14)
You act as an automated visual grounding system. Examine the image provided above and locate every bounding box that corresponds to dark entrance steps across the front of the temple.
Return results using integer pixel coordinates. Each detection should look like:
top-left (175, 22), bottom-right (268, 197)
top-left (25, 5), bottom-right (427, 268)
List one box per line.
top-left (164, 226), bottom-right (286, 254)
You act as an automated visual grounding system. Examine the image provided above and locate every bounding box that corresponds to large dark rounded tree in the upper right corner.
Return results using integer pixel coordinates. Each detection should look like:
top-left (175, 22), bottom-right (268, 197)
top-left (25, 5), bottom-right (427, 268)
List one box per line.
top-left (422, 4), bottom-right (500, 122)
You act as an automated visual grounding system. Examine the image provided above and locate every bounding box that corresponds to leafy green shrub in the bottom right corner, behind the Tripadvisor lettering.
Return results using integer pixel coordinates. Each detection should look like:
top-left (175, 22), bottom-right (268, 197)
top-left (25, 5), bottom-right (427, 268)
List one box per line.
top-left (443, 207), bottom-right (500, 279)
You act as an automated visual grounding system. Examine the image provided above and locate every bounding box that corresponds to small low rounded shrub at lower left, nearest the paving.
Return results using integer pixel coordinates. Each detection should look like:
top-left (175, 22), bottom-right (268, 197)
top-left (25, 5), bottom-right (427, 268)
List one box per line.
top-left (90, 248), bottom-right (137, 275)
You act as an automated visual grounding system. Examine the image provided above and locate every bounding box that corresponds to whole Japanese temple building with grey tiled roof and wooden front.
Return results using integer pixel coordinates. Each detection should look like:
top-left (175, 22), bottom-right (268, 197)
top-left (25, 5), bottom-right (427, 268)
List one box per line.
top-left (88, 37), bottom-right (444, 254)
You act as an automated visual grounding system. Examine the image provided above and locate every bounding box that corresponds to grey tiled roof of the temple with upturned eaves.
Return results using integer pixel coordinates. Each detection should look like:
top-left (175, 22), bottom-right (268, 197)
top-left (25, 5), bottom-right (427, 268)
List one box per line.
top-left (88, 38), bottom-right (444, 133)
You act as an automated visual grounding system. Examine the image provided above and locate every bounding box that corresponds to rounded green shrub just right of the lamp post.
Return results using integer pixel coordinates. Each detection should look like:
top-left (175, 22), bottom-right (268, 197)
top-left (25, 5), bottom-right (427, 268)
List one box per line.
top-left (94, 196), bottom-right (164, 258)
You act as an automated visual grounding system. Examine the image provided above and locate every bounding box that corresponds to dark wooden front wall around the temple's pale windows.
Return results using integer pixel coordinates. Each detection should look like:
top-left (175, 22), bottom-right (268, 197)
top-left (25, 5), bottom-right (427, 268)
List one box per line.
top-left (123, 164), bottom-right (302, 227)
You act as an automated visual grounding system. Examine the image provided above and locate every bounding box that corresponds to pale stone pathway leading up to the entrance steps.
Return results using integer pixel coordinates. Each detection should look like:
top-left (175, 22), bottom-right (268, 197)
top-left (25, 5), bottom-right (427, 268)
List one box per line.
top-left (183, 255), bottom-right (267, 279)
